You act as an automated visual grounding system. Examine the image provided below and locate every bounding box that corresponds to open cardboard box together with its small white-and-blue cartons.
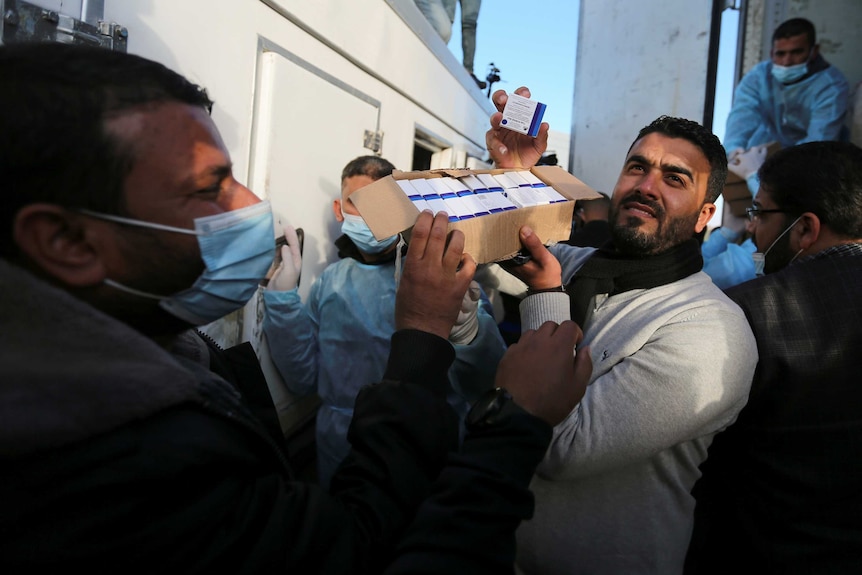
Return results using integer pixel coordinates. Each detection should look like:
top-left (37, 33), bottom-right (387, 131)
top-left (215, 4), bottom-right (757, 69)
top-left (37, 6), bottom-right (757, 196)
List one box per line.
top-left (350, 166), bottom-right (599, 263)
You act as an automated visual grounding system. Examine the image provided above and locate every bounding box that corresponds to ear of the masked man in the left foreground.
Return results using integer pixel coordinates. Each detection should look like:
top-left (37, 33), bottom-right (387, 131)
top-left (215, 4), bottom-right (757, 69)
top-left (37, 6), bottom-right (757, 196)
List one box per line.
top-left (12, 203), bottom-right (105, 287)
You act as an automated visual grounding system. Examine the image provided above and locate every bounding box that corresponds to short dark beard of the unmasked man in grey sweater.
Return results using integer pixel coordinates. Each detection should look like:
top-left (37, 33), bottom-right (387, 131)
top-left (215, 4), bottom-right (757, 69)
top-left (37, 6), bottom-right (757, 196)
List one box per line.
top-left (611, 193), bottom-right (700, 256)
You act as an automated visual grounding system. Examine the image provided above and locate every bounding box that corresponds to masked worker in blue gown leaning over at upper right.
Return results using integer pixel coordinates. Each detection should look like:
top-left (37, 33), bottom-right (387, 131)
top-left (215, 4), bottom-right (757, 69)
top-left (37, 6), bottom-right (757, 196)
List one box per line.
top-left (723, 18), bottom-right (850, 195)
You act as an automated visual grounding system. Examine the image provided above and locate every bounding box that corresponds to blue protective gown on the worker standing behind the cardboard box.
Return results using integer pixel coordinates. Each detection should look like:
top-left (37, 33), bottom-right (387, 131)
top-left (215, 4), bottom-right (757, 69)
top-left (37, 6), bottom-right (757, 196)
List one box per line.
top-left (263, 240), bottom-right (506, 486)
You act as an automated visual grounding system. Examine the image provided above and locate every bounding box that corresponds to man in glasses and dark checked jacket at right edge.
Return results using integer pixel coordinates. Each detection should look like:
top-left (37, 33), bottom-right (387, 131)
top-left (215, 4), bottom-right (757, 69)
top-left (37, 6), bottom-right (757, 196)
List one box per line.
top-left (686, 142), bottom-right (862, 574)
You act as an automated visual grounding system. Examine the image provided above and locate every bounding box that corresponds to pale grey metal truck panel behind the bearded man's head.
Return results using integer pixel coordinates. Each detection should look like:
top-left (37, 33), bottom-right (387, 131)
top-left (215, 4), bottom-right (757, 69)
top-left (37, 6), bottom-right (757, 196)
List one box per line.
top-left (571, 0), bottom-right (712, 193)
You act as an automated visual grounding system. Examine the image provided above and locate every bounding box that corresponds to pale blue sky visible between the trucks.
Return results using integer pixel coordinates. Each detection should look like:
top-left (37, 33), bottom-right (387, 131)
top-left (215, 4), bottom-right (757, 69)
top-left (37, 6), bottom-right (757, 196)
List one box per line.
top-left (449, 0), bottom-right (738, 138)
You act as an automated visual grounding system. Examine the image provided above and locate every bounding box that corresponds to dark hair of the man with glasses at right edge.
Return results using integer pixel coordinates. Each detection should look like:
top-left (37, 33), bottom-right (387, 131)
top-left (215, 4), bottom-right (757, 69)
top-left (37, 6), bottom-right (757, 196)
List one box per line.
top-left (758, 142), bottom-right (862, 238)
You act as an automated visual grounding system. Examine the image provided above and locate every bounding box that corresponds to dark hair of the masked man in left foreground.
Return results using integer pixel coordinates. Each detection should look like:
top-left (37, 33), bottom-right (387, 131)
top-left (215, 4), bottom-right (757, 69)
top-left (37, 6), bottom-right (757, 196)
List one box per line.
top-left (0, 42), bottom-right (212, 257)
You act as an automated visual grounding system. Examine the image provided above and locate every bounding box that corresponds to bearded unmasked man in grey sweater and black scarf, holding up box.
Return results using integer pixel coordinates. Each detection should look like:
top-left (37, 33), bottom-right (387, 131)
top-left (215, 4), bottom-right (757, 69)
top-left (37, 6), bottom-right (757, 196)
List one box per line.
top-left (487, 88), bottom-right (757, 575)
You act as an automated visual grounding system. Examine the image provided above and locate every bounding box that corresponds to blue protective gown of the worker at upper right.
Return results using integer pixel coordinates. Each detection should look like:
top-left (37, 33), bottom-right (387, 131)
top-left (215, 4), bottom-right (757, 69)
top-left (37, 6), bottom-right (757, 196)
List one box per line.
top-left (724, 56), bottom-right (850, 153)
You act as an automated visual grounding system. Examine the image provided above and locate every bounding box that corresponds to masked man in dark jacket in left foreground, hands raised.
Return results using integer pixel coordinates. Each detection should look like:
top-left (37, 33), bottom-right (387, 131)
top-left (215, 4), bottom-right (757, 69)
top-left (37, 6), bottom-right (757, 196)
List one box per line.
top-left (0, 43), bottom-right (591, 575)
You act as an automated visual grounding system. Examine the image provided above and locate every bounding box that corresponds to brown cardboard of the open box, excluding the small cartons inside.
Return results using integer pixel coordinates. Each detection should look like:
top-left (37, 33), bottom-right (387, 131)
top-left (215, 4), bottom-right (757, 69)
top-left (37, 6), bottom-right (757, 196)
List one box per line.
top-left (350, 166), bottom-right (599, 264)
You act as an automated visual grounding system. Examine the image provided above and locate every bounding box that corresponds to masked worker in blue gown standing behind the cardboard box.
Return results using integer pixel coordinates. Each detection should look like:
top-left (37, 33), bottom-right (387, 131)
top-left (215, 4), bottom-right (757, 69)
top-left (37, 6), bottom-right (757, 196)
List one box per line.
top-left (263, 156), bottom-right (506, 487)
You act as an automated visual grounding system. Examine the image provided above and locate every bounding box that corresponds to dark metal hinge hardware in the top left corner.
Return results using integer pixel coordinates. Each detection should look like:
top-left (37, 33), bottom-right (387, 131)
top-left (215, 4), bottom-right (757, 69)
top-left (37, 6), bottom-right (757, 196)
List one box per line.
top-left (2, 0), bottom-right (129, 52)
